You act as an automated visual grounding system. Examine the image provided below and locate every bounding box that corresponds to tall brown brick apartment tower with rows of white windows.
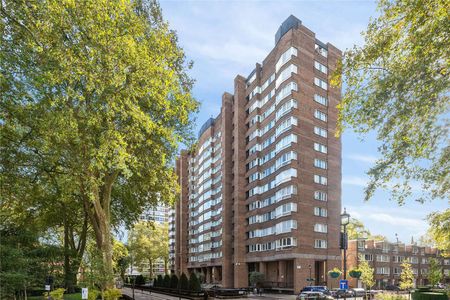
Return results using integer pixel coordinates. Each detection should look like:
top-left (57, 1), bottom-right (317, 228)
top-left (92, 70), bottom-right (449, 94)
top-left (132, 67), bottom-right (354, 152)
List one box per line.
top-left (175, 16), bottom-right (341, 292)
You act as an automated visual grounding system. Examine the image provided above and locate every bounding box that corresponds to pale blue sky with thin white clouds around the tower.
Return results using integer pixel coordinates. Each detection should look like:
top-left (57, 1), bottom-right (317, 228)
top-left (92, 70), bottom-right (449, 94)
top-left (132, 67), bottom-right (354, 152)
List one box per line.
top-left (161, 0), bottom-right (448, 242)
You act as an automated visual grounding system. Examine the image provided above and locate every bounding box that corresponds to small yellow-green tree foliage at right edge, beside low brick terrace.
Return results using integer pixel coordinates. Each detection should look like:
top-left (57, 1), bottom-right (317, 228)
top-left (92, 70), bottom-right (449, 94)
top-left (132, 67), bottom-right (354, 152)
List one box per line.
top-left (428, 208), bottom-right (450, 257)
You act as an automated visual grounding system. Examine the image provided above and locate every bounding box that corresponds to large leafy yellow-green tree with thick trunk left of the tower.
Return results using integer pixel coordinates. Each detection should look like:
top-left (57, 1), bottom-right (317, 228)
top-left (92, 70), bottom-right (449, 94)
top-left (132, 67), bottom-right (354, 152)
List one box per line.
top-left (0, 0), bottom-right (198, 286)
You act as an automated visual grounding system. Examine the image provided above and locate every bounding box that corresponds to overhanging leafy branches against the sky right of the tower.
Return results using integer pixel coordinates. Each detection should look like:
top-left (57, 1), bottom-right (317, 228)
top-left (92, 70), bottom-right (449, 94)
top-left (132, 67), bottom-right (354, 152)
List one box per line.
top-left (332, 0), bottom-right (450, 204)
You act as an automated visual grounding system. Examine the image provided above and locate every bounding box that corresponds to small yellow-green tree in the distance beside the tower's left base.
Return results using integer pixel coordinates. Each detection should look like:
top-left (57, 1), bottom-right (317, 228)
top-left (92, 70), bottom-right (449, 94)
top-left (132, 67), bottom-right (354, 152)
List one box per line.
top-left (128, 221), bottom-right (169, 278)
